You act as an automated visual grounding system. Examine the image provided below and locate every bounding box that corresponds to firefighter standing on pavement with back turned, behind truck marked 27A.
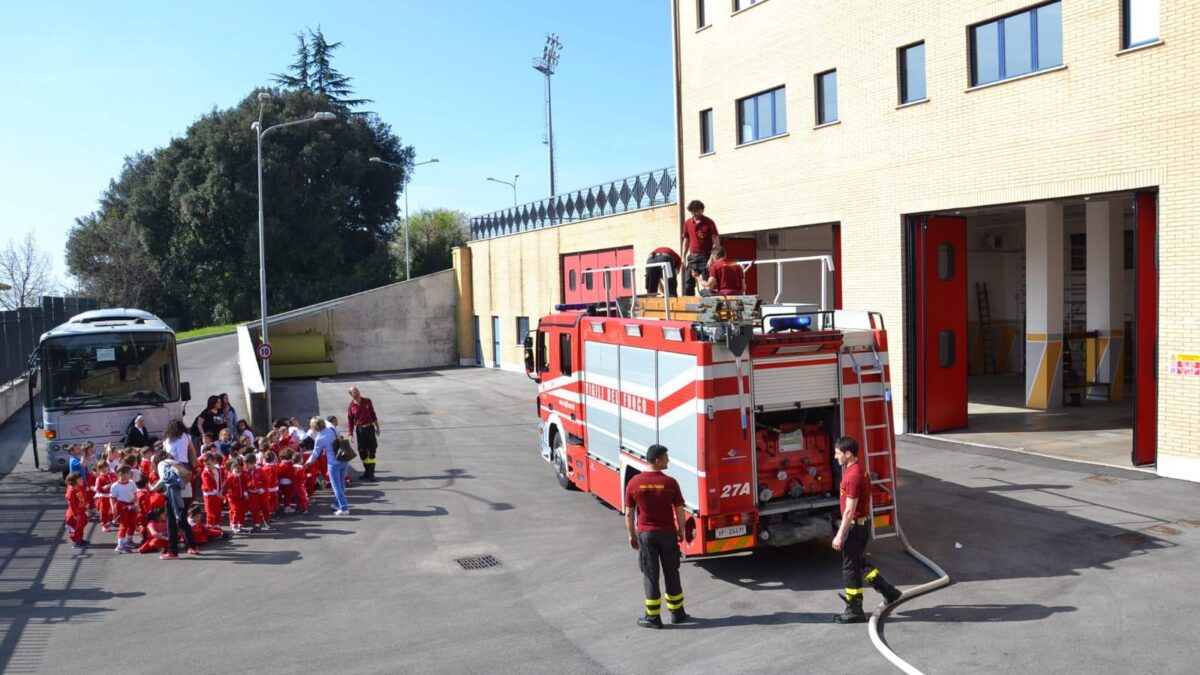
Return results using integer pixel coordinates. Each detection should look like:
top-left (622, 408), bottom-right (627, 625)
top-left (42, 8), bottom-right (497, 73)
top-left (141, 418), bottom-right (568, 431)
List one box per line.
top-left (625, 444), bottom-right (690, 628)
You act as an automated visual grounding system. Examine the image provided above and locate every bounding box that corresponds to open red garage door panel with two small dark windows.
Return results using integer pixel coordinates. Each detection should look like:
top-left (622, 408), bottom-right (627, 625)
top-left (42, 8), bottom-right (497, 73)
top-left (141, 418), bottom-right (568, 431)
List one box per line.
top-left (910, 216), bottom-right (970, 434)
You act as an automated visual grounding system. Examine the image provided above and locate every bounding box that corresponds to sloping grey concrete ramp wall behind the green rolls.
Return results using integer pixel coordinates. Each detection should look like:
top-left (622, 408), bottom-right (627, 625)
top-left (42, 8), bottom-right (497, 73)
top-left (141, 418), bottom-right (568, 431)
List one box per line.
top-left (271, 269), bottom-right (457, 374)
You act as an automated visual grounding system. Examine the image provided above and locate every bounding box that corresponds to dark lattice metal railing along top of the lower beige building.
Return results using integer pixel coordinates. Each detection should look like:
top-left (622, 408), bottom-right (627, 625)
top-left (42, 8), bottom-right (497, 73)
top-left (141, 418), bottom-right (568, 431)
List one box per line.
top-left (470, 167), bottom-right (679, 240)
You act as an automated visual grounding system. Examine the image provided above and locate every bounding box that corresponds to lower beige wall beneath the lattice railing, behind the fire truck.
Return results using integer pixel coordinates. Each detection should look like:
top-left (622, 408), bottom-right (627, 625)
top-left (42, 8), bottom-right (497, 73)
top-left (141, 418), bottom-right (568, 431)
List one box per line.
top-left (456, 204), bottom-right (679, 370)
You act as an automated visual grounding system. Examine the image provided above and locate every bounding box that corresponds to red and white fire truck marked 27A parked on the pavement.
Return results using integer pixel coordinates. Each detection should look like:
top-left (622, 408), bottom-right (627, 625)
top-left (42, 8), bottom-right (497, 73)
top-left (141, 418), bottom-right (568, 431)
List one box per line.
top-left (524, 258), bottom-right (895, 557)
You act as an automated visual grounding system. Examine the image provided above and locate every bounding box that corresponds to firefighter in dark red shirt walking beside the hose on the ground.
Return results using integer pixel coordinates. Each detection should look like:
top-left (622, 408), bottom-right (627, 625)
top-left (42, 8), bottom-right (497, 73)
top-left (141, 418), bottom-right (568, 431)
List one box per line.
top-left (833, 436), bottom-right (900, 623)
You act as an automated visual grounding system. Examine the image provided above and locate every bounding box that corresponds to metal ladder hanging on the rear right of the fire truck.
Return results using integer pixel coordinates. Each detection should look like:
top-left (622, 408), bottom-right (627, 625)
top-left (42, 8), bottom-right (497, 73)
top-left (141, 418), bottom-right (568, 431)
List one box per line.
top-left (844, 344), bottom-right (898, 539)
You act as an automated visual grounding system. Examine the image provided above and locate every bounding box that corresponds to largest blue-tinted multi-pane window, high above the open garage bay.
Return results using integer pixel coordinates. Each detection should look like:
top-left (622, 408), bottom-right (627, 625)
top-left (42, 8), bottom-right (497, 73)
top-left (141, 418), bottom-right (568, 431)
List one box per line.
top-left (971, 1), bottom-right (1062, 86)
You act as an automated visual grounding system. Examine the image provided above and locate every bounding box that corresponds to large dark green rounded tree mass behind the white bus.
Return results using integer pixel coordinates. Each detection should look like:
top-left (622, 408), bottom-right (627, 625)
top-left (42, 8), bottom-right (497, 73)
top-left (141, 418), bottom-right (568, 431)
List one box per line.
top-left (67, 89), bottom-right (413, 324)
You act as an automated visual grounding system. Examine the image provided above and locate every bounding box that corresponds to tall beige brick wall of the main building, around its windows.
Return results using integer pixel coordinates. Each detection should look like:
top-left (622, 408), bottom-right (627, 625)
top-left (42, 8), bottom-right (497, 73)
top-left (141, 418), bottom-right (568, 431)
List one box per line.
top-left (677, 0), bottom-right (1200, 468)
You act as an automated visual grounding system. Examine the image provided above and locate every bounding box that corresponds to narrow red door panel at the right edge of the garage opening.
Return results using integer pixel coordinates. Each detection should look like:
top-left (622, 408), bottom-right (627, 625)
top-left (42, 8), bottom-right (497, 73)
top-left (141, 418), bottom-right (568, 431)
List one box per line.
top-left (1133, 192), bottom-right (1158, 466)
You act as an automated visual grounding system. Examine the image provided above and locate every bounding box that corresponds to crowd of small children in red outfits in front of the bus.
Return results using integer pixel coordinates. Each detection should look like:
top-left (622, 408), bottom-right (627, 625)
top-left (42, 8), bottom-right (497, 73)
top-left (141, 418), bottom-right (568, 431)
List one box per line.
top-left (65, 418), bottom-right (345, 554)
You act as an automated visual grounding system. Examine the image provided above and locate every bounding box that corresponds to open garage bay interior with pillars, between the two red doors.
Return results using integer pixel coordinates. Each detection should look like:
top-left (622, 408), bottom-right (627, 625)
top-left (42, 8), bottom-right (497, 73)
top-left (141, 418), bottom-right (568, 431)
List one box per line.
top-left (937, 193), bottom-right (1136, 467)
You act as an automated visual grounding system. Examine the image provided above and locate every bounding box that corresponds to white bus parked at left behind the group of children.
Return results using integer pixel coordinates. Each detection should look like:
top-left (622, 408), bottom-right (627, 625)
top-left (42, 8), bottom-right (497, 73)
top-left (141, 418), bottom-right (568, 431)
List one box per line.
top-left (35, 309), bottom-right (191, 471)
